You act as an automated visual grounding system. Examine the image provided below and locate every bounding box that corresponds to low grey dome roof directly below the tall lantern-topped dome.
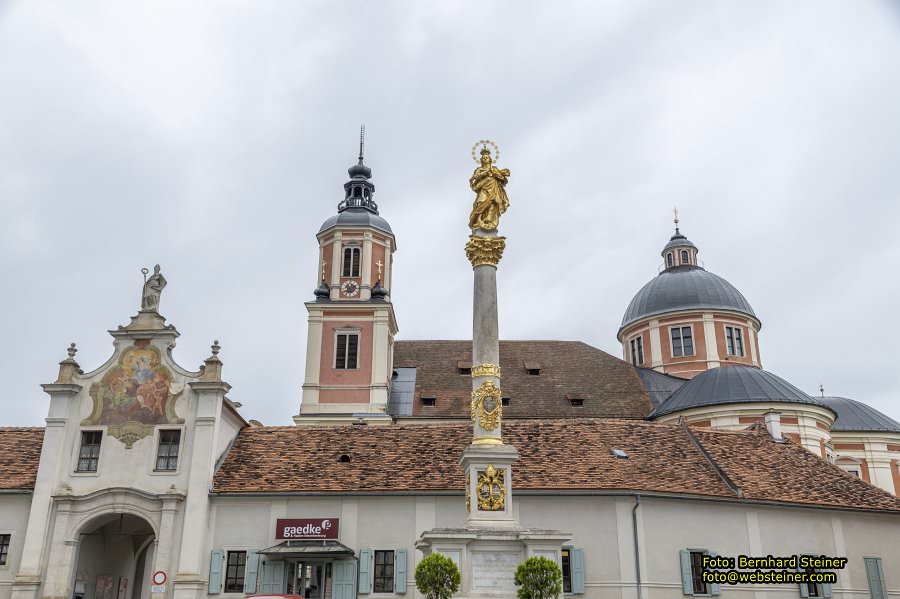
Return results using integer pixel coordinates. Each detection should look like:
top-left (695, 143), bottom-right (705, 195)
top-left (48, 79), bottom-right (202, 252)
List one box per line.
top-left (650, 365), bottom-right (834, 418)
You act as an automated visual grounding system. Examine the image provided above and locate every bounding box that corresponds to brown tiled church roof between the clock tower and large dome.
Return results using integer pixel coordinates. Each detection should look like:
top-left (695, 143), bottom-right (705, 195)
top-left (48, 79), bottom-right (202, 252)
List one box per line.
top-left (394, 341), bottom-right (653, 419)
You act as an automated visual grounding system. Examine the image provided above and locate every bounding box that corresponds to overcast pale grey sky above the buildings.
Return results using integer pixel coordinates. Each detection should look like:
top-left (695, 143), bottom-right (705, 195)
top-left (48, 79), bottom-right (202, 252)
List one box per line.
top-left (0, 0), bottom-right (900, 425)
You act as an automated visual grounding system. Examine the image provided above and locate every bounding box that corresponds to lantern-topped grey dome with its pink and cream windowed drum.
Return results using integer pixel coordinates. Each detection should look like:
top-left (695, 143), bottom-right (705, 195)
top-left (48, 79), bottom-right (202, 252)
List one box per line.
top-left (618, 213), bottom-right (761, 378)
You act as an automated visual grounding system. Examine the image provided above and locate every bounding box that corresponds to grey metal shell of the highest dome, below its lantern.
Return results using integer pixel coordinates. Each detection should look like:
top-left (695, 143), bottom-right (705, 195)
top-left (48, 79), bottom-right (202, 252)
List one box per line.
top-left (619, 264), bottom-right (759, 331)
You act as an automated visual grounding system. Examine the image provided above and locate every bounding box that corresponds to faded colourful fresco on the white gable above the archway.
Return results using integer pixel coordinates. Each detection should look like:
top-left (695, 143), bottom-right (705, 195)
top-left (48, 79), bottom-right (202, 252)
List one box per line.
top-left (81, 344), bottom-right (184, 449)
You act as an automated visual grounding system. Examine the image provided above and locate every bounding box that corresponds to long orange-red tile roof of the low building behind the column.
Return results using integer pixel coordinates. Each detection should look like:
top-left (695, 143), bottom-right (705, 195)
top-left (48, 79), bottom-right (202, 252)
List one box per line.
top-left (213, 419), bottom-right (900, 513)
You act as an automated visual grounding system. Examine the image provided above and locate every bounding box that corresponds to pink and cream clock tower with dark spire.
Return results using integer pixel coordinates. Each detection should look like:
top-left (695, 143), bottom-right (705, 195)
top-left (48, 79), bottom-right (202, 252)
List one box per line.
top-left (294, 130), bottom-right (397, 424)
